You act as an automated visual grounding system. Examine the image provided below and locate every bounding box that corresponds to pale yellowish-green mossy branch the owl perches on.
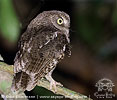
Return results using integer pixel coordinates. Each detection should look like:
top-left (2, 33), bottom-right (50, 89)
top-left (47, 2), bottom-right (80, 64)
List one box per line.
top-left (0, 62), bottom-right (92, 100)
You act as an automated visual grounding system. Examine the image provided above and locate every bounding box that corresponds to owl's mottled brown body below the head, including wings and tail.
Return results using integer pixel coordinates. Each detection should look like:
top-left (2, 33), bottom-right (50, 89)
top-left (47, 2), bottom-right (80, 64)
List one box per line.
top-left (12, 32), bottom-right (70, 91)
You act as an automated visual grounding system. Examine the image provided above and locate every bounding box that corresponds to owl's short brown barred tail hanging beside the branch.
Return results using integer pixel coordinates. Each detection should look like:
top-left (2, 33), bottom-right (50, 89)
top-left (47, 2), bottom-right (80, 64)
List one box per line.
top-left (11, 71), bottom-right (38, 91)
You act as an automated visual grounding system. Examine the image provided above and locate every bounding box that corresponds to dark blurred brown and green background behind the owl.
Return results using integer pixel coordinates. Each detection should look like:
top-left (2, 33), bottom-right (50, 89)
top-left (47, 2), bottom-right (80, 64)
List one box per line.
top-left (0, 0), bottom-right (117, 100)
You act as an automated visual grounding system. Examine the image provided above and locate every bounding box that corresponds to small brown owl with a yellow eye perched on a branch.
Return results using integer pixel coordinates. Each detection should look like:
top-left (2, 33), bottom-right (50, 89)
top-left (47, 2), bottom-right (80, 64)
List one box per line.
top-left (11, 10), bottom-right (71, 91)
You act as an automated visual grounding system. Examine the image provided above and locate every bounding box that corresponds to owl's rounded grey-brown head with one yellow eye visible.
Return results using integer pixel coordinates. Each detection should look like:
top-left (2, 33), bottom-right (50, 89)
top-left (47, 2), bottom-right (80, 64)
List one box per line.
top-left (28, 10), bottom-right (70, 42)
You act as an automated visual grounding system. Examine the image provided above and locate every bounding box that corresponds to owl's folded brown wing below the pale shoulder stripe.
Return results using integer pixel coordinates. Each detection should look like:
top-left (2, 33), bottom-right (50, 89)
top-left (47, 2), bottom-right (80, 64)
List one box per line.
top-left (27, 34), bottom-right (67, 76)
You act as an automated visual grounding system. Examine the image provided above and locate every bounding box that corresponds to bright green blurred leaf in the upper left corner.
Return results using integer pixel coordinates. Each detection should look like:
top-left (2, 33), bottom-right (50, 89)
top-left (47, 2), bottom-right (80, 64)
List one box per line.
top-left (0, 0), bottom-right (19, 42)
